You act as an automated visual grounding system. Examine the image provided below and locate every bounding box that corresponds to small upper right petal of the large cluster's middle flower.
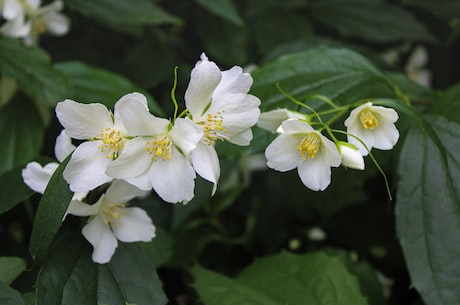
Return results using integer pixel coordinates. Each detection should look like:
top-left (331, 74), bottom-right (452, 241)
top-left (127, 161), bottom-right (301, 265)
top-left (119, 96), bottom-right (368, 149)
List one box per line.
top-left (169, 118), bottom-right (203, 155)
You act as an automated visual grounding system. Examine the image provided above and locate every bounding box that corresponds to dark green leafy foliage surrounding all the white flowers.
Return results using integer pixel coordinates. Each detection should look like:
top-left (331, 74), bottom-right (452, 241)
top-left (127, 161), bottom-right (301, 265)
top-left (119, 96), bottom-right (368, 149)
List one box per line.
top-left (0, 0), bottom-right (460, 305)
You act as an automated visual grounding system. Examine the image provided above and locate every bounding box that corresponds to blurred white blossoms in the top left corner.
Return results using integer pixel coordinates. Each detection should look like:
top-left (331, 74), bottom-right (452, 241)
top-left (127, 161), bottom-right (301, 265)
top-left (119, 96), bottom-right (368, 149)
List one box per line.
top-left (0, 0), bottom-right (70, 45)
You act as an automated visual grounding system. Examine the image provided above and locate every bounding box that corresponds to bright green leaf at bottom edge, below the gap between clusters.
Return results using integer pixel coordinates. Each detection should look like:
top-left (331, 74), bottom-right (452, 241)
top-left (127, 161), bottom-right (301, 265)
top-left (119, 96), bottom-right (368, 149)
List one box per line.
top-left (192, 252), bottom-right (367, 305)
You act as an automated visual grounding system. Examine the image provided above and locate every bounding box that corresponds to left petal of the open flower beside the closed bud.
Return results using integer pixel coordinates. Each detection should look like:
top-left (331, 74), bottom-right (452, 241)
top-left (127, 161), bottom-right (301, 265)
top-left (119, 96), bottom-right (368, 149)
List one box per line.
top-left (265, 134), bottom-right (303, 172)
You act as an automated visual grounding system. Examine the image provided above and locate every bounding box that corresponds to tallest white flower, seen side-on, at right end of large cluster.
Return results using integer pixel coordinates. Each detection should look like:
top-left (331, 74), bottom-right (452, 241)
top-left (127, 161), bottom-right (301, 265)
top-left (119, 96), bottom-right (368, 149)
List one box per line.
top-left (185, 53), bottom-right (260, 194)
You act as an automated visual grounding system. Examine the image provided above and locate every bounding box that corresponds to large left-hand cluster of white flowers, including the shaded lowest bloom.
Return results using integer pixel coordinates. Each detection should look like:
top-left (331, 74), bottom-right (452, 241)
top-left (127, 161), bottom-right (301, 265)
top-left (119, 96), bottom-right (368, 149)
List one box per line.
top-left (23, 54), bottom-right (260, 263)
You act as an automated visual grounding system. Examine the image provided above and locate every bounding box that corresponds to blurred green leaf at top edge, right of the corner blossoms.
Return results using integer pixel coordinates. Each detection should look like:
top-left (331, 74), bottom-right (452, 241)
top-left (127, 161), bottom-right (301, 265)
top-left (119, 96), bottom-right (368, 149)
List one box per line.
top-left (64, 0), bottom-right (180, 31)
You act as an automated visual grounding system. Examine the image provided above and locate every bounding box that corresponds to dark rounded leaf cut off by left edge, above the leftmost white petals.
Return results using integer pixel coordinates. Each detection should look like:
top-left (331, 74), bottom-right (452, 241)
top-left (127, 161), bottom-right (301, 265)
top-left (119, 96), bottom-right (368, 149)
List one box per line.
top-left (0, 98), bottom-right (44, 175)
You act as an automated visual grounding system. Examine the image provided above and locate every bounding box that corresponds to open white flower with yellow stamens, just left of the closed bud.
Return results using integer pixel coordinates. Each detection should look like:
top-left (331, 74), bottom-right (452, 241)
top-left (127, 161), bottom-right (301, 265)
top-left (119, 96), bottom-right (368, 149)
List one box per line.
top-left (265, 120), bottom-right (341, 191)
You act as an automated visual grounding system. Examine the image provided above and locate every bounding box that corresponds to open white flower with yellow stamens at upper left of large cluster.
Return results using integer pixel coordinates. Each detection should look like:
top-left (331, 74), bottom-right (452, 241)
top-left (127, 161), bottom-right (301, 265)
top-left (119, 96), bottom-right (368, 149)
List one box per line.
top-left (56, 93), bottom-right (147, 192)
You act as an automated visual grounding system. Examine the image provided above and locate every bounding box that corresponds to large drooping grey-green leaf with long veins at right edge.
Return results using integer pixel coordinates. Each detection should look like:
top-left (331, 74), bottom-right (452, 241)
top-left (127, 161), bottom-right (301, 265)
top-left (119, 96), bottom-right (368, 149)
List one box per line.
top-left (396, 116), bottom-right (460, 305)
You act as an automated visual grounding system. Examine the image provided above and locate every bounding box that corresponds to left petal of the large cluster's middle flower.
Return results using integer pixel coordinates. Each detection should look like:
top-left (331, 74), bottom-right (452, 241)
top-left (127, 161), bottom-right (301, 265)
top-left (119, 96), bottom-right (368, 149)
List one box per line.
top-left (106, 137), bottom-right (152, 179)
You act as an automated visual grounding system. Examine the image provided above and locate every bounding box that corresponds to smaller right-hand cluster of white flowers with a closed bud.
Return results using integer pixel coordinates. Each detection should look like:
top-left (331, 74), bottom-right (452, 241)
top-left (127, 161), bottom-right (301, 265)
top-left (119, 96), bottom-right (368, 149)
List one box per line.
top-left (258, 102), bottom-right (399, 191)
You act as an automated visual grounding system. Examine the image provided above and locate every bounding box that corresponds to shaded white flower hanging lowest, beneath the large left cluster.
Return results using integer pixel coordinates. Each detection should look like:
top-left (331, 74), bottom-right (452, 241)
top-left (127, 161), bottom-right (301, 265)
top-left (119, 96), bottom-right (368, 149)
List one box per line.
top-left (67, 180), bottom-right (155, 264)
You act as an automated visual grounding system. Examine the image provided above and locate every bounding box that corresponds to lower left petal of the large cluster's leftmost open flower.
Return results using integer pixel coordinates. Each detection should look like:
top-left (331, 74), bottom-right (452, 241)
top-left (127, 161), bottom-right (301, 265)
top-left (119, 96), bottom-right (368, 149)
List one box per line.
top-left (63, 141), bottom-right (112, 192)
